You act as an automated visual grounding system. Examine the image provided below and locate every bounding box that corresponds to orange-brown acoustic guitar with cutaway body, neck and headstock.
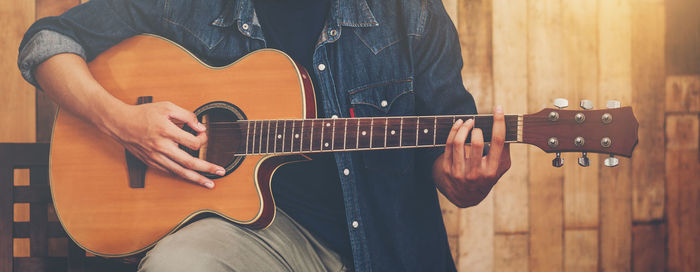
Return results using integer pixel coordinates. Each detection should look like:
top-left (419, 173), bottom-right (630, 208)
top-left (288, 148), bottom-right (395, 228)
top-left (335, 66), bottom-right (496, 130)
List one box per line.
top-left (50, 35), bottom-right (638, 257)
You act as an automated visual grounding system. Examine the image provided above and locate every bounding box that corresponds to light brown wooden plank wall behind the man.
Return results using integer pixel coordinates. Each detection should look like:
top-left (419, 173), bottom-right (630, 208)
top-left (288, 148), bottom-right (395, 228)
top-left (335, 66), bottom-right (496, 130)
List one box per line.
top-left (0, 0), bottom-right (700, 271)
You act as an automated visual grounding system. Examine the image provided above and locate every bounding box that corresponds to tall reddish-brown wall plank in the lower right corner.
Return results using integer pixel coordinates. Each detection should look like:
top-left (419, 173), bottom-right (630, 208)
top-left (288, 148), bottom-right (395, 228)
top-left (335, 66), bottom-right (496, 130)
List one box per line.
top-left (666, 114), bottom-right (700, 271)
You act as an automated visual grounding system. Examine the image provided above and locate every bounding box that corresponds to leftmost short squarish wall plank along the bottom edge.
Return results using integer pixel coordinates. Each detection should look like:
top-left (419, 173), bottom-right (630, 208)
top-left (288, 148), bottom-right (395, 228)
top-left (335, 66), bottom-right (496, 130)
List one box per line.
top-left (490, 234), bottom-right (529, 272)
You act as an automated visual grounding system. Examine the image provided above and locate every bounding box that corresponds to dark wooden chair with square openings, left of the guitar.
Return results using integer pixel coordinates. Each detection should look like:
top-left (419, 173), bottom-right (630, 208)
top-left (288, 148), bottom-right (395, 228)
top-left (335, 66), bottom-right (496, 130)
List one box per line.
top-left (0, 143), bottom-right (136, 272)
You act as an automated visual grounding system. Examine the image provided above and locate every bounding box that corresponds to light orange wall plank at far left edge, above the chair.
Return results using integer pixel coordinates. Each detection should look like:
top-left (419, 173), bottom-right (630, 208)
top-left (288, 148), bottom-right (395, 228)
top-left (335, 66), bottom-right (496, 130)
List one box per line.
top-left (0, 1), bottom-right (35, 142)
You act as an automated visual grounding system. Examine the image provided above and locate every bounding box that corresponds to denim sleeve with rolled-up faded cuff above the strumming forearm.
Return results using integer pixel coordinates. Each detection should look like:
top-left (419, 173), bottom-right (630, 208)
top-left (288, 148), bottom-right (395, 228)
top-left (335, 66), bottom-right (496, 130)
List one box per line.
top-left (17, 0), bottom-right (163, 86)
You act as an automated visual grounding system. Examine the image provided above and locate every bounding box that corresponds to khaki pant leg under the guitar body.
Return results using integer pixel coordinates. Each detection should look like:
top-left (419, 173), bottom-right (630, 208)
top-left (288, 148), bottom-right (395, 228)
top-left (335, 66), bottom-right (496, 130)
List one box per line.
top-left (139, 209), bottom-right (345, 272)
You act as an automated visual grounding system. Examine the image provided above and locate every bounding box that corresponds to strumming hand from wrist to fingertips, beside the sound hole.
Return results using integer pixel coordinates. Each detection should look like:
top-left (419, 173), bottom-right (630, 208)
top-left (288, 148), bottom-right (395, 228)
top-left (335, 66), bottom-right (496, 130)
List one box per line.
top-left (99, 102), bottom-right (225, 189)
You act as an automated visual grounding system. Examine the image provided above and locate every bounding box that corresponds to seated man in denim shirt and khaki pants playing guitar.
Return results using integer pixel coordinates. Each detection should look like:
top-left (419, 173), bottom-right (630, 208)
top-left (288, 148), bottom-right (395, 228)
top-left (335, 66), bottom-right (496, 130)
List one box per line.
top-left (19, 0), bottom-right (510, 271)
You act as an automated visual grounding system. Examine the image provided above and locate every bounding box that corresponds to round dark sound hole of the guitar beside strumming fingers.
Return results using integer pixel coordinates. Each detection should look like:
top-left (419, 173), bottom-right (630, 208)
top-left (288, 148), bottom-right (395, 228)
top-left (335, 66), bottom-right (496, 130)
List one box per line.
top-left (180, 102), bottom-right (246, 178)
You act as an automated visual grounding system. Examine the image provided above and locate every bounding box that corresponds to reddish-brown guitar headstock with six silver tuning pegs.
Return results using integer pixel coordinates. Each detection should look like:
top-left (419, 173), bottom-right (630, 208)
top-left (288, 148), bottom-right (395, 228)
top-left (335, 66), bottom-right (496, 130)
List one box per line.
top-left (522, 99), bottom-right (639, 167)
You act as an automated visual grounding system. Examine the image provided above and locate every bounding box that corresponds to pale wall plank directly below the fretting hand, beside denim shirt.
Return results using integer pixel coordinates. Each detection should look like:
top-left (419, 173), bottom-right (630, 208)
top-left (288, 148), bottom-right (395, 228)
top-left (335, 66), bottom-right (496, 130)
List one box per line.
top-left (457, 194), bottom-right (494, 271)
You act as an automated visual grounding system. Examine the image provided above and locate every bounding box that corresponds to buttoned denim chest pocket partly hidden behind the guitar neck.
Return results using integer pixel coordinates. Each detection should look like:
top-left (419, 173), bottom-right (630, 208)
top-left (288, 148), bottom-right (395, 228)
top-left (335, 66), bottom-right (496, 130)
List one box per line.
top-left (348, 78), bottom-right (415, 175)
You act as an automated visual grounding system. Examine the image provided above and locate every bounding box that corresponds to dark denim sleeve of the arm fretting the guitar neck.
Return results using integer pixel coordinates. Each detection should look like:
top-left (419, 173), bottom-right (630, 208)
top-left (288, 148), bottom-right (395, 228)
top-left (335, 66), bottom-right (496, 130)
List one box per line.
top-left (413, 0), bottom-right (477, 183)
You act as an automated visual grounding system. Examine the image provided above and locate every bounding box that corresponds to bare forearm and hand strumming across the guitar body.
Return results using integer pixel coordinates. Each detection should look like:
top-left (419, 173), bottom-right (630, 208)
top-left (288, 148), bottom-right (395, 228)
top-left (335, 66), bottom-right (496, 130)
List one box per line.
top-left (34, 54), bottom-right (224, 188)
